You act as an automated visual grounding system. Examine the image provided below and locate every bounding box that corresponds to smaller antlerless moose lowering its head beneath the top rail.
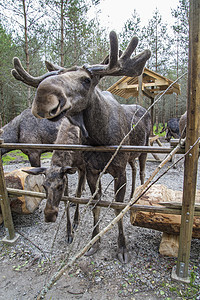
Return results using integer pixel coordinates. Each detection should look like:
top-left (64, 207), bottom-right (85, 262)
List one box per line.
top-left (25, 118), bottom-right (86, 243)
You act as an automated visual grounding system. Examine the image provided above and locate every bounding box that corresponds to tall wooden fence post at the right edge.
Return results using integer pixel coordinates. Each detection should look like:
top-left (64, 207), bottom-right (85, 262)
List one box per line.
top-left (172, 0), bottom-right (200, 283)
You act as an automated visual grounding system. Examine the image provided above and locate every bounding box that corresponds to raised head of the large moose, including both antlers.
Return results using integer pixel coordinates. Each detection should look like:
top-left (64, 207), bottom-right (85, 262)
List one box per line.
top-left (12, 31), bottom-right (151, 119)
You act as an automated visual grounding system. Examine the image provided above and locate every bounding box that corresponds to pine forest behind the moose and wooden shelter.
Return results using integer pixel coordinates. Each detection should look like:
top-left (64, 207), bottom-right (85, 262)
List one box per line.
top-left (0, 0), bottom-right (189, 127)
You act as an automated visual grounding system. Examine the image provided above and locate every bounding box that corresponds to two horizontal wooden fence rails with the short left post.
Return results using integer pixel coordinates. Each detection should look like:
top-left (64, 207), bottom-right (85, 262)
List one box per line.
top-left (0, 141), bottom-right (200, 281)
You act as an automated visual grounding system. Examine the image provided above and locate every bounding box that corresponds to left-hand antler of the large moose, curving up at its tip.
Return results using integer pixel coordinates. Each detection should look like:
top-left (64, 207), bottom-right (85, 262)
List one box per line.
top-left (11, 57), bottom-right (64, 88)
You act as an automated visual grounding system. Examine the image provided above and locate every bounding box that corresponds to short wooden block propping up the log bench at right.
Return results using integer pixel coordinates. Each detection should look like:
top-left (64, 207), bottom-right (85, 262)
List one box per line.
top-left (159, 232), bottom-right (179, 257)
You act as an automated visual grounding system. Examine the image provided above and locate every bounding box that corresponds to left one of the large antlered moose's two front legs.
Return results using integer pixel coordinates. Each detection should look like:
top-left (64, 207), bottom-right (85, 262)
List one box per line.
top-left (85, 172), bottom-right (101, 256)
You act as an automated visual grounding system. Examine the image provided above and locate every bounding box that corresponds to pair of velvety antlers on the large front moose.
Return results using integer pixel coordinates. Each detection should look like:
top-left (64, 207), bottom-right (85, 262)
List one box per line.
top-left (11, 31), bottom-right (151, 88)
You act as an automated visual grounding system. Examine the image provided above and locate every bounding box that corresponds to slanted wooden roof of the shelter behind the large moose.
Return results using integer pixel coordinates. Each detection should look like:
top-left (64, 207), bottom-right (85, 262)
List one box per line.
top-left (108, 68), bottom-right (180, 99)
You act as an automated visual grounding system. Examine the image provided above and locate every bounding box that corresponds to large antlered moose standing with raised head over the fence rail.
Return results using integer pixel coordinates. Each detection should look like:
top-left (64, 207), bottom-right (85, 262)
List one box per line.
top-left (12, 32), bottom-right (150, 263)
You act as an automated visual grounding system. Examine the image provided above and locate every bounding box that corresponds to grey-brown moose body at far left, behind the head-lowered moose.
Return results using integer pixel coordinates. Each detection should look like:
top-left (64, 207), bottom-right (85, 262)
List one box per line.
top-left (0, 108), bottom-right (62, 167)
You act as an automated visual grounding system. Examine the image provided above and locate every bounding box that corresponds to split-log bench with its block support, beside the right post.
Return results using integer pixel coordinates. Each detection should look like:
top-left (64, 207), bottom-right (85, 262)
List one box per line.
top-left (130, 184), bottom-right (200, 257)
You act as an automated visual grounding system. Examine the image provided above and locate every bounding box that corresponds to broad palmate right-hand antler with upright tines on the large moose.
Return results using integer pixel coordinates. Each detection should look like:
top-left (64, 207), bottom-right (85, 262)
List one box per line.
top-left (83, 31), bottom-right (151, 77)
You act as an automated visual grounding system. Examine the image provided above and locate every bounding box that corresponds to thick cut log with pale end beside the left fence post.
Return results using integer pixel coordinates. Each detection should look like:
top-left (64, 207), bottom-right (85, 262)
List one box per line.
top-left (1, 167), bottom-right (44, 214)
